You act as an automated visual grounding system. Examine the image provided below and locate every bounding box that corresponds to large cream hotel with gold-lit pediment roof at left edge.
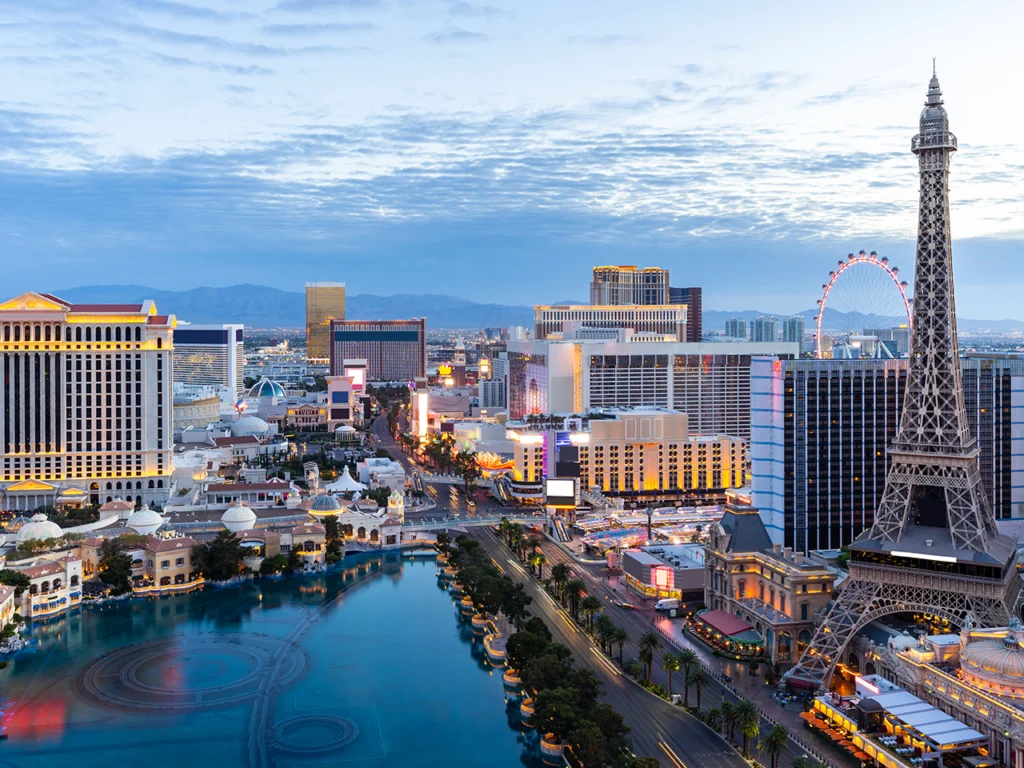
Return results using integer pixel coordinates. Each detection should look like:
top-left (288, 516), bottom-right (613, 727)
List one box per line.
top-left (0, 293), bottom-right (175, 510)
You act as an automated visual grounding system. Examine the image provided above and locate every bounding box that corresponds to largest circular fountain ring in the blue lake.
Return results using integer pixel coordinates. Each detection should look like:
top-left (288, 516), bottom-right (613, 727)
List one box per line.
top-left (76, 635), bottom-right (309, 712)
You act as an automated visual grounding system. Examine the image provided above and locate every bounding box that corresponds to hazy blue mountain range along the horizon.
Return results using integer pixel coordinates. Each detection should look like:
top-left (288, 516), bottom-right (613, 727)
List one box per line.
top-left (50, 284), bottom-right (1024, 333)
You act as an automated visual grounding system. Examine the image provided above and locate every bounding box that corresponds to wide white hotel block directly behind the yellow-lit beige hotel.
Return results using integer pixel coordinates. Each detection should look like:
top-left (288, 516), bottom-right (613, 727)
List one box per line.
top-left (508, 332), bottom-right (799, 440)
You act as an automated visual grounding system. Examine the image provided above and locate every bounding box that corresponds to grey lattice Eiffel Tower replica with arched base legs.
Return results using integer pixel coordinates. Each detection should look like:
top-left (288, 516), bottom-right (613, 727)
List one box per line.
top-left (786, 62), bottom-right (1022, 685)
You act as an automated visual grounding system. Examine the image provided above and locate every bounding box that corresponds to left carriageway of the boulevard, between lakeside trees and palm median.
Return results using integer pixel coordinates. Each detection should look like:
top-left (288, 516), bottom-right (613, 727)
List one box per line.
top-left (469, 527), bottom-right (749, 768)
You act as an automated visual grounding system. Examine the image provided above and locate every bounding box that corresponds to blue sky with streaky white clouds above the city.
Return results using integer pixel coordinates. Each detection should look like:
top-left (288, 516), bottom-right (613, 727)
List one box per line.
top-left (0, 0), bottom-right (1024, 318)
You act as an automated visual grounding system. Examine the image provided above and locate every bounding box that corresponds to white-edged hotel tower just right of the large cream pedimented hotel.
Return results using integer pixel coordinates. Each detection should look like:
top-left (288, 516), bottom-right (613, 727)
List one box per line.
top-left (174, 324), bottom-right (245, 400)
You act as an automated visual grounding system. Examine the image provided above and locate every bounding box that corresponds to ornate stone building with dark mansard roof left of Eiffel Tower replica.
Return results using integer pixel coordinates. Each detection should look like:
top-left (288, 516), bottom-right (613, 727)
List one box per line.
top-left (705, 504), bottom-right (837, 664)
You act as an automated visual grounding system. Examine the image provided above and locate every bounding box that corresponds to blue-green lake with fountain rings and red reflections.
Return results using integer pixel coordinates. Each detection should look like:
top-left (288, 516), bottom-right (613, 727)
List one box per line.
top-left (0, 553), bottom-right (541, 768)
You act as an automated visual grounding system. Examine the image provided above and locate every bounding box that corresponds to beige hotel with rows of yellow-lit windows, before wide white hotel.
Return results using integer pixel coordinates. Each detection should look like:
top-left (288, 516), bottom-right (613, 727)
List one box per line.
top-left (507, 409), bottom-right (746, 502)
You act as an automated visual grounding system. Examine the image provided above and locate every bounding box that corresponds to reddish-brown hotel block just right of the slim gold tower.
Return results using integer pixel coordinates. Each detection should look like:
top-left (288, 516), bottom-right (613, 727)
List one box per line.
top-left (331, 317), bottom-right (427, 382)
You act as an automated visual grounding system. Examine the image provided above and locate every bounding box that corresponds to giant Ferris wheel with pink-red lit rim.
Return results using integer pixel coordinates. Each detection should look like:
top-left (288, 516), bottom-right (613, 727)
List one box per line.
top-left (814, 251), bottom-right (913, 358)
